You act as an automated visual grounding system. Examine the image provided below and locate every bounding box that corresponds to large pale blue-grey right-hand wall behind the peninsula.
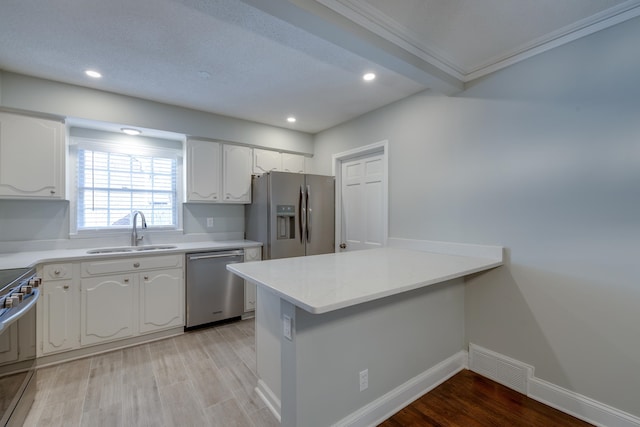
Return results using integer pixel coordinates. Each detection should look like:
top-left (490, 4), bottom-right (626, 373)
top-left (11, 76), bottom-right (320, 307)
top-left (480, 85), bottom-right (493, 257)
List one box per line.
top-left (313, 15), bottom-right (640, 416)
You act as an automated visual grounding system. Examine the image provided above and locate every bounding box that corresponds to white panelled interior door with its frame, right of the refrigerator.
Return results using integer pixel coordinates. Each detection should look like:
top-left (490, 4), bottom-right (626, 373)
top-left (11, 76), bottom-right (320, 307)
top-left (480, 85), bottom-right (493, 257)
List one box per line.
top-left (336, 144), bottom-right (388, 251)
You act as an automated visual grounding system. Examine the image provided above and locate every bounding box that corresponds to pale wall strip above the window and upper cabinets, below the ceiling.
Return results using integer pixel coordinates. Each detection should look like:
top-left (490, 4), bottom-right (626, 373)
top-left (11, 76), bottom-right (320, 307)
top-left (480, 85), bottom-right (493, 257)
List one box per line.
top-left (0, 72), bottom-right (313, 153)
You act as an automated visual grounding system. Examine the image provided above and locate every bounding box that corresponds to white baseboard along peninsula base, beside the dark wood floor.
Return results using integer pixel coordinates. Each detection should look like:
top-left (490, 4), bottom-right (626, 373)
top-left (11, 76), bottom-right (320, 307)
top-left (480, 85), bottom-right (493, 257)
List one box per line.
top-left (333, 351), bottom-right (468, 427)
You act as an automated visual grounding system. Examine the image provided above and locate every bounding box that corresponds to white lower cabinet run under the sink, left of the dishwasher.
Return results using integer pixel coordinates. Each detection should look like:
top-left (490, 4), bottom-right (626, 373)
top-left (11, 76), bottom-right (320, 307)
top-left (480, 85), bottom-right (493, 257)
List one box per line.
top-left (36, 254), bottom-right (184, 354)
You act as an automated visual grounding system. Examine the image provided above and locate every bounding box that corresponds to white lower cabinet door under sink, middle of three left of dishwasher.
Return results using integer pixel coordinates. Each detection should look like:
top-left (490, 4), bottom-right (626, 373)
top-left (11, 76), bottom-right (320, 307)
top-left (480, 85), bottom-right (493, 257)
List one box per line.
top-left (80, 275), bottom-right (137, 345)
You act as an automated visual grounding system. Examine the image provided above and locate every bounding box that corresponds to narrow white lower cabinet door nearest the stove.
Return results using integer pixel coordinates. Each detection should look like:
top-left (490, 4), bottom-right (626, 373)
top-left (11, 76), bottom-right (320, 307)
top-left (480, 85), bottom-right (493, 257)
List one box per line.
top-left (38, 280), bottom-right (80, 354)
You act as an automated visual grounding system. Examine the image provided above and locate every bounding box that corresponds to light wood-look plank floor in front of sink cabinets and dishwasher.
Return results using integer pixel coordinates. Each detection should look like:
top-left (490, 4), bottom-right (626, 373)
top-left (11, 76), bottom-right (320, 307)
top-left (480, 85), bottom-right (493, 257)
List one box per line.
top-left (25, 319), bottom-right (279, 427)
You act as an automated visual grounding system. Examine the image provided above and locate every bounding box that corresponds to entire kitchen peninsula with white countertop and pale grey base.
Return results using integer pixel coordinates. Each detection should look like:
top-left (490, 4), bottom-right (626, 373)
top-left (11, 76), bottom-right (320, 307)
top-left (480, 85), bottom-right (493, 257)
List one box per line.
top-left (227, 239), bottom-right (502, 427)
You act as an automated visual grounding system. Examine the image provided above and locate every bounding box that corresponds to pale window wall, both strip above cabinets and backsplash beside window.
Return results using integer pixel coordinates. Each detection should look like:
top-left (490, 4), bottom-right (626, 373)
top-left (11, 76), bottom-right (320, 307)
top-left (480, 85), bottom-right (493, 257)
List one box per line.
top-left (0, 71), bottom-right (313, 244)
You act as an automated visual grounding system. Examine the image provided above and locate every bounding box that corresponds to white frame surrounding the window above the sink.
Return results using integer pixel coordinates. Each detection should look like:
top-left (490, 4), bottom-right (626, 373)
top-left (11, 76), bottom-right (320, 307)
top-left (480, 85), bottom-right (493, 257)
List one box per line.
top-left (67, 133), bottom-right (184, 237)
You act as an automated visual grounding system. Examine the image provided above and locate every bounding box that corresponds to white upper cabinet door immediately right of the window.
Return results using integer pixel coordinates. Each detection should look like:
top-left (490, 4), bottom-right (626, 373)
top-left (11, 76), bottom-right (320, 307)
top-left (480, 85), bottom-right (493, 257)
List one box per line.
top-left (186, 139), bottom-right (222, 202)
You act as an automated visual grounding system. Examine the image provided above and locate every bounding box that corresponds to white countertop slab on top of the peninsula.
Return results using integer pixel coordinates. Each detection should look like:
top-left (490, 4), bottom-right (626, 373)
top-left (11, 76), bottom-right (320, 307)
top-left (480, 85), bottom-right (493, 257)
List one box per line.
top-left (227, 247), bottom-right (502, 314)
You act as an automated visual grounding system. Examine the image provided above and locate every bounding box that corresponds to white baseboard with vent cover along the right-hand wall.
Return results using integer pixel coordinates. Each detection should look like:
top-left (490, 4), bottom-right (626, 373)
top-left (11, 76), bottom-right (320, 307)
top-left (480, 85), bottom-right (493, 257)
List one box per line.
top-left (469, 344), bottom-right (640, 427)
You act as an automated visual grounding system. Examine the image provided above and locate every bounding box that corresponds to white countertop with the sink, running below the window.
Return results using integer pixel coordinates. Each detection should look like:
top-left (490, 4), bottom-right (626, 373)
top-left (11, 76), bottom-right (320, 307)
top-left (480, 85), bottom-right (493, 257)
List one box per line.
top-left (0, 240), bottom-right (262, 269)
